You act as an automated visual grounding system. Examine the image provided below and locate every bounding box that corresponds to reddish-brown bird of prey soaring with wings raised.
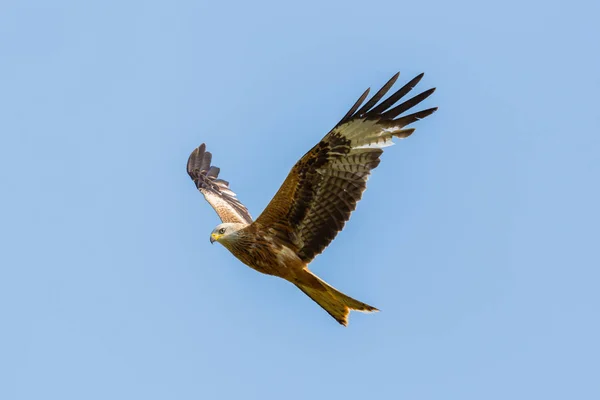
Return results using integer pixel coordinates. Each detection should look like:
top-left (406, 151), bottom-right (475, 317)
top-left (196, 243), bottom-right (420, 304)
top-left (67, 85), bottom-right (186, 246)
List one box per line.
top-left (187, 73), bottom-right (437, 326)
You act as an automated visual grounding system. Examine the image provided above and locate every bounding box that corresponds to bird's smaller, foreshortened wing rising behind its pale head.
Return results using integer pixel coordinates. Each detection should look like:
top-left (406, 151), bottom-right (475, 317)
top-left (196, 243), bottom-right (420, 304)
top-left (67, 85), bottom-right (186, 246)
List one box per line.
top-left (187, 143), bottom-right (252, 224)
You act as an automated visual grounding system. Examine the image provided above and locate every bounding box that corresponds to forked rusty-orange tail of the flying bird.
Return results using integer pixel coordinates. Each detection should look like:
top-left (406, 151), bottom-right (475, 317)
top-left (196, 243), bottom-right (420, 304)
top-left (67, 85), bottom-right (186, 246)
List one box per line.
top-left (295, 270), bottom-right (379, 326)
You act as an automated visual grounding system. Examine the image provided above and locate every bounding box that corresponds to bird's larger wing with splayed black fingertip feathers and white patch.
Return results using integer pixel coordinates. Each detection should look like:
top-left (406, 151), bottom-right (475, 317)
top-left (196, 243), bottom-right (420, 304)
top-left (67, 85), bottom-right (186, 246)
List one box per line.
top-left (256, 74), bottom-right (437, 262)
